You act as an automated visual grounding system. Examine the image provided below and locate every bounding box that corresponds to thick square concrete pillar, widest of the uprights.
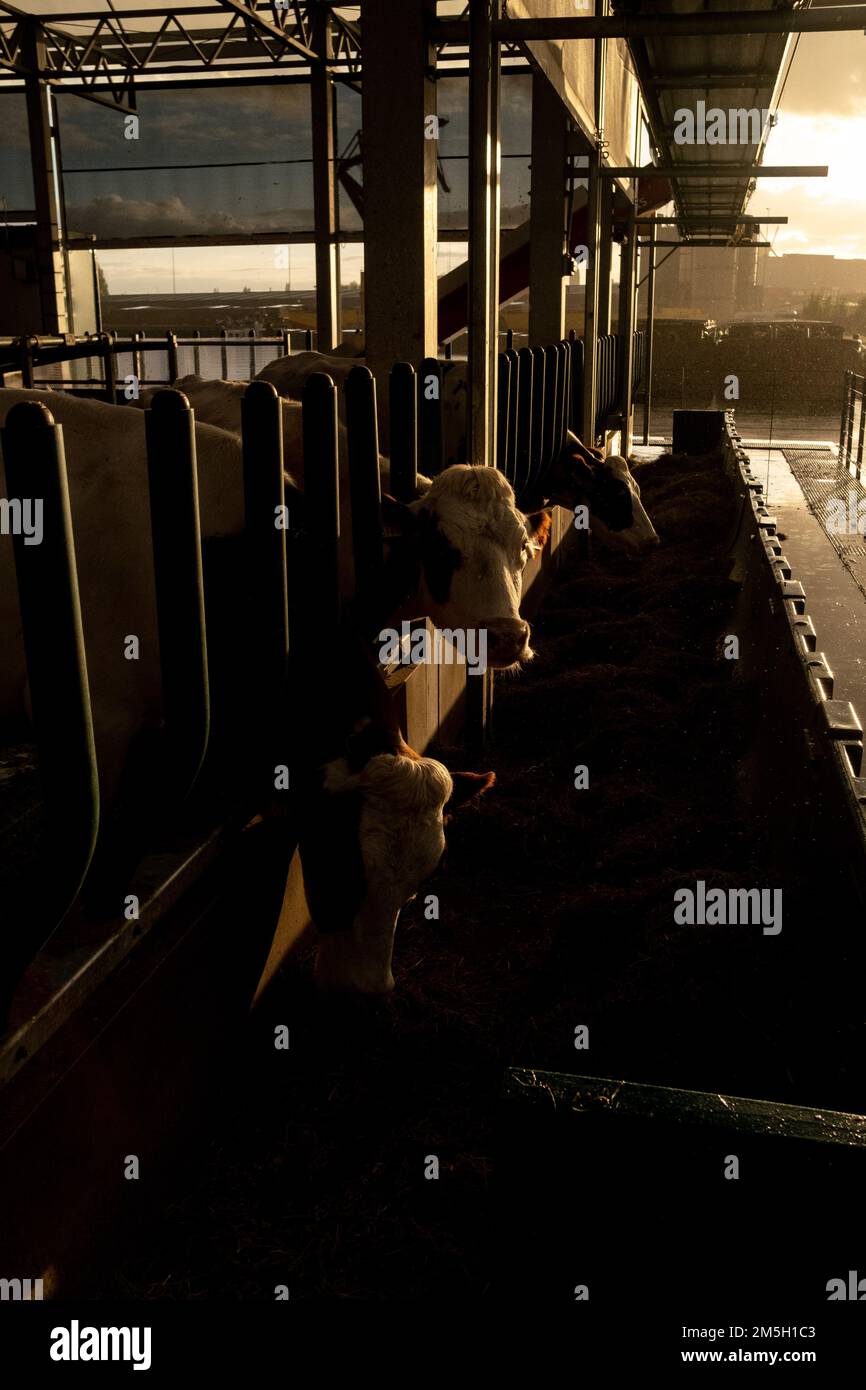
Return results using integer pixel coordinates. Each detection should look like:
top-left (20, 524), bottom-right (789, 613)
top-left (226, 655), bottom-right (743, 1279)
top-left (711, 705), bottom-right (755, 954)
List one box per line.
top-left (361, 0), bottom-right (438, 380)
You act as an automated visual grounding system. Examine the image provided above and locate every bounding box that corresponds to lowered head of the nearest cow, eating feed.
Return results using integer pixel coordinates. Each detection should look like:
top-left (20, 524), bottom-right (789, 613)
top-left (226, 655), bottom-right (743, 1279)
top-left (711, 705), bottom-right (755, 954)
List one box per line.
top-left (300, 720), bottom-right (496, 994)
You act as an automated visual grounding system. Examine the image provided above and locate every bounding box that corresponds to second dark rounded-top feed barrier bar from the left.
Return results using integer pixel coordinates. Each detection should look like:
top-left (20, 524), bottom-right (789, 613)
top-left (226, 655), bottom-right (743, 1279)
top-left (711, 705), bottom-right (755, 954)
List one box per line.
top-left (145, 389), bottom-right (210, 795)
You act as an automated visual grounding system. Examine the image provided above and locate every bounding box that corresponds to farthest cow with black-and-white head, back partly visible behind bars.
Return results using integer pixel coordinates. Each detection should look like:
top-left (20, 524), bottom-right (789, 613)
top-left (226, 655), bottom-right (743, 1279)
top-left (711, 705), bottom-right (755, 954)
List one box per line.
top-left (256, 352), bottom-right (659, 553)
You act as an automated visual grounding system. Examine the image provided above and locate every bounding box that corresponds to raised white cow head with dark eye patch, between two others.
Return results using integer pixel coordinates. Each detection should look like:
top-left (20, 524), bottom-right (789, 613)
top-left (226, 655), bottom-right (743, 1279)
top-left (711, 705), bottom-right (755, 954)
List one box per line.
top-left (385, 463), bottom-right (550, 667)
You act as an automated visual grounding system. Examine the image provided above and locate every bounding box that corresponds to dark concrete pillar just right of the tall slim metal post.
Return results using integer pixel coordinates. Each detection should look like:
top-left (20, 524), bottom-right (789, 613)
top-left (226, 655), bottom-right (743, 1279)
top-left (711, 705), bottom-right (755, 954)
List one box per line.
top-left (530, 72), bottom-right (567, 348)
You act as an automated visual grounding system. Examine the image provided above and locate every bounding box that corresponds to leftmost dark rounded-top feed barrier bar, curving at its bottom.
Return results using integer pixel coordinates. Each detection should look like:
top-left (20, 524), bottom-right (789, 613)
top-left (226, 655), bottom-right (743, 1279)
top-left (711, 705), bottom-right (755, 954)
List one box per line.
top-left (0, 400), bottom-right (99, 961)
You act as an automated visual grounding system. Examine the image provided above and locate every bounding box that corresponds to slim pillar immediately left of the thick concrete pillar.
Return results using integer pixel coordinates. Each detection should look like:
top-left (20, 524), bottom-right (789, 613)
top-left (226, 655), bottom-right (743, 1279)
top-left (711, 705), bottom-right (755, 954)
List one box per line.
top-left (310, 10), bottom-right (342, 352)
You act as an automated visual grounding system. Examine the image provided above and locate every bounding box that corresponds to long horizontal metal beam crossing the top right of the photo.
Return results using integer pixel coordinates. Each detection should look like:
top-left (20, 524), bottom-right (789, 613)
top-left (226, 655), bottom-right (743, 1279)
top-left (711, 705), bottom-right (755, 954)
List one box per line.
top-left (434, 4), bottom-right (866, 43)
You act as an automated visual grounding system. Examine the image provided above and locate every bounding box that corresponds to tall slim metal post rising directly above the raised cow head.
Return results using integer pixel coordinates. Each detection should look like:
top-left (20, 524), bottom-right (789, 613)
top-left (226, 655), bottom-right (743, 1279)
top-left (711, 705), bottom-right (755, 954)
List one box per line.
top-left (467, 0), bottom-right (499, 464)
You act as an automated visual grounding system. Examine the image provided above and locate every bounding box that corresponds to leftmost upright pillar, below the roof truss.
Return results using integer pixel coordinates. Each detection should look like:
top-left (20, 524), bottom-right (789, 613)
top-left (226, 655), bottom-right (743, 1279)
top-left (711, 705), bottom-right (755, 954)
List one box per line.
top-left (22, 24), bottom-right (68, 334)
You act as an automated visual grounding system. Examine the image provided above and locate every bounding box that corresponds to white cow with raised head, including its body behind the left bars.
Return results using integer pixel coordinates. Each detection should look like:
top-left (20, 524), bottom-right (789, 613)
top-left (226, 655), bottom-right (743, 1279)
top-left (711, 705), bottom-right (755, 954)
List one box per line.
top-left (0, 389), bottom-right (544, 802)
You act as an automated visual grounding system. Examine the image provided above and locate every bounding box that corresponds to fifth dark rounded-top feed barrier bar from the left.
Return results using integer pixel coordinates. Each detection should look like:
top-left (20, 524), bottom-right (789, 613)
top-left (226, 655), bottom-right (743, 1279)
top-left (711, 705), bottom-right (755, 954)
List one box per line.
top-left (345, 367), bottom-right (382, 610)
